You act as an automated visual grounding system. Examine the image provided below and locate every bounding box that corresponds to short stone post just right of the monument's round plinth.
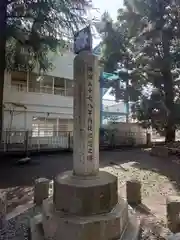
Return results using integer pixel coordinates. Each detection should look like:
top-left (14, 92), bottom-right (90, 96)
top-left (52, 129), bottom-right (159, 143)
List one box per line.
top-left (126, 180), bottom-right (141, 205)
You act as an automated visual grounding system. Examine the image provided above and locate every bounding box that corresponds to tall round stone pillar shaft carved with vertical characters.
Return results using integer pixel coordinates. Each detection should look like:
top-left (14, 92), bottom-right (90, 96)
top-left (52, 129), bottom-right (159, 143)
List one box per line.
top-left (73, 51), bottom-right (100, 176)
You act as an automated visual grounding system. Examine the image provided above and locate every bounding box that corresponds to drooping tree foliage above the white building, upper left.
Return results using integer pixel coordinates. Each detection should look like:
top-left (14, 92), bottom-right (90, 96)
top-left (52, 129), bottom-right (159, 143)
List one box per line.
top-left (3, 0), bottom-right (90, 71)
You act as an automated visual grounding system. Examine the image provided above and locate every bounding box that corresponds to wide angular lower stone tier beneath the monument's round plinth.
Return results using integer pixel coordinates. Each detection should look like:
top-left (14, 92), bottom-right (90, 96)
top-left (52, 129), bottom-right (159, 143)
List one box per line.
top-left (42, 199), bottom-right (128, 240)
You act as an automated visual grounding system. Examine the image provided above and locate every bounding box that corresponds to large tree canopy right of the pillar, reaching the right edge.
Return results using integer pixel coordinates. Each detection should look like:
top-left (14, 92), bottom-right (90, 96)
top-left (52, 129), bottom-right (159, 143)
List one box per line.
top-left (102, 0), bottom-right (180, 141)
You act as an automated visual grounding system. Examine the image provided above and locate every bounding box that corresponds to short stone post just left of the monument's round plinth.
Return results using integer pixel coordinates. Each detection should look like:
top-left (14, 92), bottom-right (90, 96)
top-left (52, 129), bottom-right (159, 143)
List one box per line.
top-left (34, 178), bottom-right (50, 205)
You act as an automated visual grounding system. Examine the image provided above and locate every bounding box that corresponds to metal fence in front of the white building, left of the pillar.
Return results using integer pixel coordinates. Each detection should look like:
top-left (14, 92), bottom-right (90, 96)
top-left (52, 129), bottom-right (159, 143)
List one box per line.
top-left (0, 130), bottom-right (73, 152)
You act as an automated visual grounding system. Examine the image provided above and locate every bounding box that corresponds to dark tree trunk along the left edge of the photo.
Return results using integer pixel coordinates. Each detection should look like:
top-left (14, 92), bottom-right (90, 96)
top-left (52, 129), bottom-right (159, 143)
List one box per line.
top-left (0, 0), bottom-right (7, 140)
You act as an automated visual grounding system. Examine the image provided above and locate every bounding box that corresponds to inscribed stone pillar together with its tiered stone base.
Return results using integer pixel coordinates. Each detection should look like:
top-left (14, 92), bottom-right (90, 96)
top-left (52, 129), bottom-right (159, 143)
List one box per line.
top-left (31, 27), bottom-right (139, 240)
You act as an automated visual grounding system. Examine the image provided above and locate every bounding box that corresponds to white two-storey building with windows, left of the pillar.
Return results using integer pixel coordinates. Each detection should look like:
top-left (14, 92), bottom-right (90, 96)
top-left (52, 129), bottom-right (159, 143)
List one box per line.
top-left (4, 48), bottom-right (74, 136)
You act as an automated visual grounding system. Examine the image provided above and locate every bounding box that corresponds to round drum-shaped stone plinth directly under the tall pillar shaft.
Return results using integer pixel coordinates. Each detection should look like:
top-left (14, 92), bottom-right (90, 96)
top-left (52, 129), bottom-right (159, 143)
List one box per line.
top-left (53, 171), bottom-right (118, 216)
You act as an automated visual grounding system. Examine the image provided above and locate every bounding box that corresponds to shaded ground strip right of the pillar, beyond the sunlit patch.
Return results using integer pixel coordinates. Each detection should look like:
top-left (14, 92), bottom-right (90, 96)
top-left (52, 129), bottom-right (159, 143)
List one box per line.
top-left (102, 149), bottom-right (180, 192)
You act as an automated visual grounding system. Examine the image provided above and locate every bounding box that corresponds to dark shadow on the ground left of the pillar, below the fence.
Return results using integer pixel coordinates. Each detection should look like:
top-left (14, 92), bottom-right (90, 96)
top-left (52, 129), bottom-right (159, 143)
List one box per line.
top-left (0, 153), bottom-right (72, 189)
